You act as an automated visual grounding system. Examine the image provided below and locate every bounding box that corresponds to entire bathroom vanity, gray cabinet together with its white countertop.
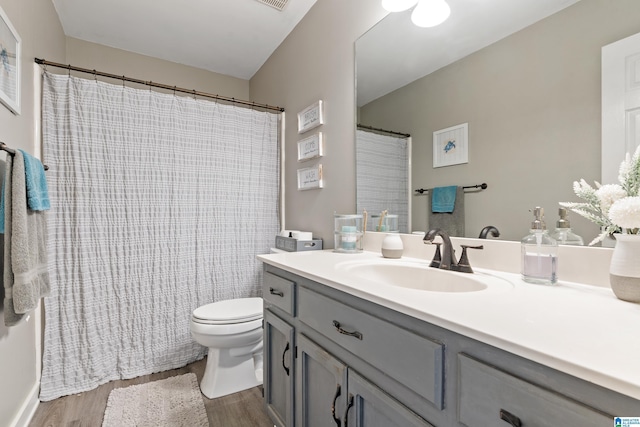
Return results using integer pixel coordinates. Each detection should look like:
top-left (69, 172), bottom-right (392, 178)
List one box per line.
top-left (259, 251), bottom-right (640, 427)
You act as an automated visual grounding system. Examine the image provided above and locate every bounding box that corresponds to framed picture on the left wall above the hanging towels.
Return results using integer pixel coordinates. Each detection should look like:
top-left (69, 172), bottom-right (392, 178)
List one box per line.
top-left (0, 8), bottom-right (21, 115)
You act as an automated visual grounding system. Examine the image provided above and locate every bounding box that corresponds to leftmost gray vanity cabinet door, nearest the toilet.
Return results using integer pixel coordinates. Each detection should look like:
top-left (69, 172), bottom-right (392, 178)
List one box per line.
top-left (264, 310), bottom-right (295, 427)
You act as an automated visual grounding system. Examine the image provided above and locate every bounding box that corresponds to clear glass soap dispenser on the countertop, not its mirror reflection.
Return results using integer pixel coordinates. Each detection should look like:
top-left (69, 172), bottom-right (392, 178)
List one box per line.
top-left (521, 207), bottom-right (558, 285)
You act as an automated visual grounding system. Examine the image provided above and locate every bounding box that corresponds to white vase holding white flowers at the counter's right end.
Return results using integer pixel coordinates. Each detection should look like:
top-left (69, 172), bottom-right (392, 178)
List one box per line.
top-left (609, 234), bottom-right (640, 303)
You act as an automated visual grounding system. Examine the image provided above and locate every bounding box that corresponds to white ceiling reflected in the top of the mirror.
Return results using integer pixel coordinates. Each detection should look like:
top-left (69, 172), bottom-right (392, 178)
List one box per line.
top-left (356, 0), bottom-right (579, 106)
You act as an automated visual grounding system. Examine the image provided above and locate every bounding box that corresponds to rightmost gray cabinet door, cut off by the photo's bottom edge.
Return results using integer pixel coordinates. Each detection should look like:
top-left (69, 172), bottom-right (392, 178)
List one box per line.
top-left (343, 369), bottom-right (433, 427)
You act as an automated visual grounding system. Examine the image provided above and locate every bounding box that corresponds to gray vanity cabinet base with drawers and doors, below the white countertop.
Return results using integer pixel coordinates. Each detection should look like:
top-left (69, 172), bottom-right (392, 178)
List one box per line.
top-left (264, 265), bottom-right (640, 427)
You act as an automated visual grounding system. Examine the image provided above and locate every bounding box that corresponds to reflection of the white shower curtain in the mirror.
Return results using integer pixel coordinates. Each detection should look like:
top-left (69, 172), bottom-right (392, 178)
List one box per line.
top-left (356, 130), bottom-right (409, 233)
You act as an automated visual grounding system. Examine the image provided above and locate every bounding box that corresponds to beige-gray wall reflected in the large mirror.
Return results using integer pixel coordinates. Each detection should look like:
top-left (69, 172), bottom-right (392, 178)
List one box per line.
top-left (360, 0), bottom-right (640, 243)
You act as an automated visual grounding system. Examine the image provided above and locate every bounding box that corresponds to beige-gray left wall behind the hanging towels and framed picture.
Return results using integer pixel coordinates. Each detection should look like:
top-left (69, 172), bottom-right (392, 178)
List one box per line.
top-left (0, 0), bottom-right (65, 426)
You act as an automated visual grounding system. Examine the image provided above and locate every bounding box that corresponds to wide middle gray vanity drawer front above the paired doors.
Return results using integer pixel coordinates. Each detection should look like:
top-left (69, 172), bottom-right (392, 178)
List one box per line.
top-left (298, 287), bottom-right (444, 409)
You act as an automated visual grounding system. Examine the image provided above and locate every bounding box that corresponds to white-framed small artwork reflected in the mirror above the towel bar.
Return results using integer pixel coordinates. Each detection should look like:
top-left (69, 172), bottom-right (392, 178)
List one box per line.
top-left (433, 123), bottom-right (469, 168)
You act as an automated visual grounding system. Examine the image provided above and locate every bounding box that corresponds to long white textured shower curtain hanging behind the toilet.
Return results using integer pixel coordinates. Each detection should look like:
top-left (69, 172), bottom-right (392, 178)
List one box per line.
top-left (40, 73), bottom-right (280, 401)
